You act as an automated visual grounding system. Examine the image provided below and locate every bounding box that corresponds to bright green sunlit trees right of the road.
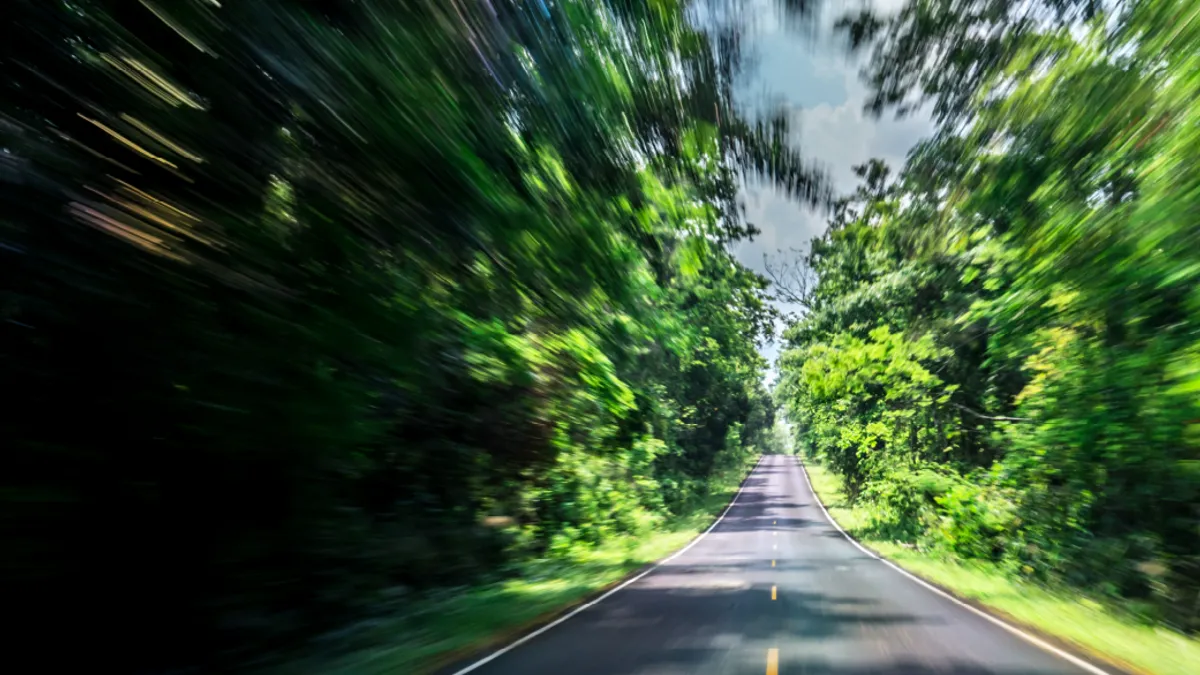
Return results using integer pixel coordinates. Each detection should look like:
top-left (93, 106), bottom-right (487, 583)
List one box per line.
top-left (781, 0), bottom-right (1200, 631)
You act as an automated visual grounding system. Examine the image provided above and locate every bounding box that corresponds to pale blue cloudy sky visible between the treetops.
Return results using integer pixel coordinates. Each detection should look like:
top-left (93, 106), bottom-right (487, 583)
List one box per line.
top-left (733, 0), bottom-right (932, 381)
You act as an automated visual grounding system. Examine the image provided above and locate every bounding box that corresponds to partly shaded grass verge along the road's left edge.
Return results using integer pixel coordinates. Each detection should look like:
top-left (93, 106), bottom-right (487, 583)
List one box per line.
top-left (260, 454), bottom-right (750, 675)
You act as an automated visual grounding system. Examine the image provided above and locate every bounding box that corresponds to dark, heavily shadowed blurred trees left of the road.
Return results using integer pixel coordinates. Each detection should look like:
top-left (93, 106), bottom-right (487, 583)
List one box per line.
top-left (0, 0), bottom-right (822, 669)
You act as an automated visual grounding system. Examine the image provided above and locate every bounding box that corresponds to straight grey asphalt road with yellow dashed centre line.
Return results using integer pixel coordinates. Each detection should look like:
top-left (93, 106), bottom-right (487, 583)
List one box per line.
top-left (448, 455), bottom-right (1086, 675)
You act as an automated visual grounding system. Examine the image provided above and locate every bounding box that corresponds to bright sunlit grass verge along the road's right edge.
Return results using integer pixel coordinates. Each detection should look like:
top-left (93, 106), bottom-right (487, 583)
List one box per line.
top-left (805, 456), bottom-right (1200, 675)
